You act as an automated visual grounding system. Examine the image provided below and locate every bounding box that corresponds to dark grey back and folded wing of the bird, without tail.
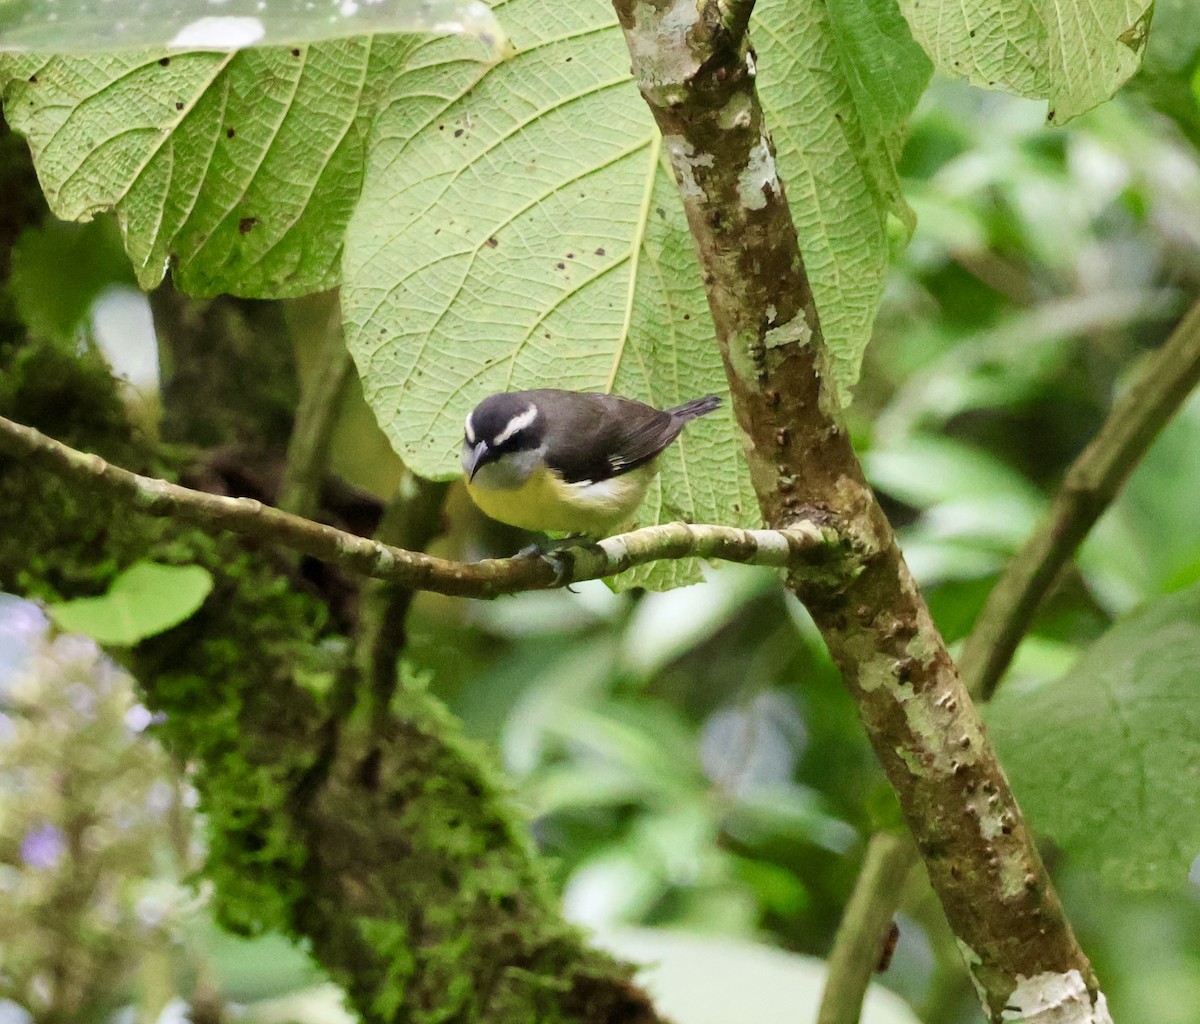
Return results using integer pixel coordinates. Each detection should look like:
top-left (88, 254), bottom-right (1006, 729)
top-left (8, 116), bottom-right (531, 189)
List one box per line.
top-left (532, 393), bottom-right (688, 484)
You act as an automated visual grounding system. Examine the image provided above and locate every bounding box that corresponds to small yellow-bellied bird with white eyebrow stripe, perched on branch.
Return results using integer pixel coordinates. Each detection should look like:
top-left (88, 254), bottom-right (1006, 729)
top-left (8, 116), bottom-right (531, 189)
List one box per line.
top-left (462, 388), bottom-right (721, 537)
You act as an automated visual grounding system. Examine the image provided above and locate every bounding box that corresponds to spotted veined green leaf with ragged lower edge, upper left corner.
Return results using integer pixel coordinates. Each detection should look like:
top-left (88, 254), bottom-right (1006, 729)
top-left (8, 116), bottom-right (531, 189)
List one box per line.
top-left (0, 37), bottom-right (432, 298)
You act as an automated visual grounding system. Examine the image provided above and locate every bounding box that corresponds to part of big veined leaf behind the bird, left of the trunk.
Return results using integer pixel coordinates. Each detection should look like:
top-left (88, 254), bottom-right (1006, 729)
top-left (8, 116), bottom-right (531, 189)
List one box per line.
top-left (342, 0), bottom-right (755, 585)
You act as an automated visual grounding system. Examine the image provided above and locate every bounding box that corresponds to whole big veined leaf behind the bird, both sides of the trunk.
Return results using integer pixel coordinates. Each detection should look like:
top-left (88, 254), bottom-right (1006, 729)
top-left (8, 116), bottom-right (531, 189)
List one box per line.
top-left (343, 0), bottom-right (929, 585)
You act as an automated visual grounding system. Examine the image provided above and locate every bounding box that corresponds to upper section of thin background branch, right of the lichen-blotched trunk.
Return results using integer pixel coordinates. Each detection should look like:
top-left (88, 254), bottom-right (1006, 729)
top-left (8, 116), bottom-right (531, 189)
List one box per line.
top-left (959, 291), bottom-right (1200, 700)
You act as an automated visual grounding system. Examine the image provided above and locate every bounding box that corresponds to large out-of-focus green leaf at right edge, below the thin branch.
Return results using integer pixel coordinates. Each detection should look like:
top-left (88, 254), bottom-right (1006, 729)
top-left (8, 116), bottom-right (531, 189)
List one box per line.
top-left (988, 586), bottom-right (1200, 888)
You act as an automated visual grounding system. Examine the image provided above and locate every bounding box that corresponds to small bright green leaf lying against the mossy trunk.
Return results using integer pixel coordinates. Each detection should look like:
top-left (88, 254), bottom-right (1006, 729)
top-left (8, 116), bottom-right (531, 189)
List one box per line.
top-left (47, 562), bottom-right (212, 647)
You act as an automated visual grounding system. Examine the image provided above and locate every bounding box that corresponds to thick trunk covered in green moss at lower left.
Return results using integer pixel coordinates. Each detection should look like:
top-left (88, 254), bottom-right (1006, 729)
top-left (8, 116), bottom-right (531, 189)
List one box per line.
top-left (0, 331), bottom-right (653, 1024)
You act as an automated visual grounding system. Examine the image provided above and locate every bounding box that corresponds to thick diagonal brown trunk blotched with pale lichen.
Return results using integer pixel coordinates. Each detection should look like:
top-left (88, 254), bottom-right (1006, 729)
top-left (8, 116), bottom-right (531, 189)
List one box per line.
top-left (614, 0), bottom-right (1108, 1024)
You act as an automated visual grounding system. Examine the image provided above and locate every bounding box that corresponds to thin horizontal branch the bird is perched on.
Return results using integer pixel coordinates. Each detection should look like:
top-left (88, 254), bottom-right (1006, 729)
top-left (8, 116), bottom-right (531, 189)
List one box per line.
top-left (0, 417), bottom-right (859, 598)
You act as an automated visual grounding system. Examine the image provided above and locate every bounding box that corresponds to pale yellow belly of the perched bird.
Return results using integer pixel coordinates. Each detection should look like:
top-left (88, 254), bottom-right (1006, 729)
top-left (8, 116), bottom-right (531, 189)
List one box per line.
top-left (467, 462), bottom-right (658, 537)
